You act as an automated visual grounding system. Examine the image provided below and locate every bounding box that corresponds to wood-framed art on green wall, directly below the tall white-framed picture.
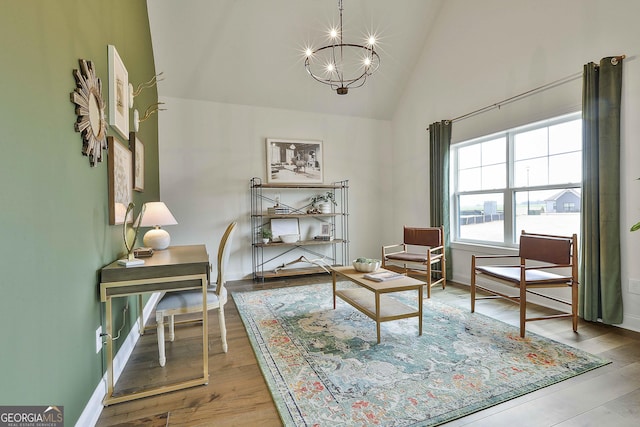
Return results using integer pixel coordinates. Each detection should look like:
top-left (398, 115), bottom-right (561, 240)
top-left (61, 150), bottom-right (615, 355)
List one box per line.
top-left (107, 136), bottom-right (133, 225)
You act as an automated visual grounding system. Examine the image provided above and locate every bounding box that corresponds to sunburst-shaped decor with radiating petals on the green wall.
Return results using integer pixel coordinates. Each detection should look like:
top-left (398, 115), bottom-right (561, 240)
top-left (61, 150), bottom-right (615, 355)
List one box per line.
top-left (71, 59), bottom-right (107, 167)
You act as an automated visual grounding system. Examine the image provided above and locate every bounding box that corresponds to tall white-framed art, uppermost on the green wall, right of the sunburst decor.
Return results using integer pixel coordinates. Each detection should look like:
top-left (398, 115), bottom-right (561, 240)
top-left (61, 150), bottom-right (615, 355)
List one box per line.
top-left (108, 45), bottom-right (129, 138)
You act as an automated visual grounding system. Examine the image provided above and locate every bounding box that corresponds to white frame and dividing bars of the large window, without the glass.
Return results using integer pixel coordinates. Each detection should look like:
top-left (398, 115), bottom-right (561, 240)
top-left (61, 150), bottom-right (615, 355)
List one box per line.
top-left (450, 111), bottom-right (584, 248)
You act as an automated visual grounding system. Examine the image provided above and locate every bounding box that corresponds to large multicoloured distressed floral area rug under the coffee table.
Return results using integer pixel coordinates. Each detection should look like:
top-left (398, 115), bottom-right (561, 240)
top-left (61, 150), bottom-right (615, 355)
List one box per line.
top-left (233, 284), bottom-right (609, 426)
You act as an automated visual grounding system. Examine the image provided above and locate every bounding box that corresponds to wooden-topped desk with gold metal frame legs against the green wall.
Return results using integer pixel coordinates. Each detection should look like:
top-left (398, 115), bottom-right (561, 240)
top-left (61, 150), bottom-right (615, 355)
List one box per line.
top-left (100, 245), bottom-right (210, 405)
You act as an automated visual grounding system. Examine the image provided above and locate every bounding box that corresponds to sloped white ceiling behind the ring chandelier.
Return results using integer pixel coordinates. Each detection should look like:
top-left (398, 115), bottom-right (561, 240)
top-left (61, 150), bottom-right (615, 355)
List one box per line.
top-left (147, 0), bottom-right (442, 119)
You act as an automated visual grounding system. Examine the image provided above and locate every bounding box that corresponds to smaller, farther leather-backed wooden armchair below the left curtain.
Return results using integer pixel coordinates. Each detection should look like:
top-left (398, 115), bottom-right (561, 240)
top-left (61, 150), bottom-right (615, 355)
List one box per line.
top-left (382, 226), bottom-right (447, 298)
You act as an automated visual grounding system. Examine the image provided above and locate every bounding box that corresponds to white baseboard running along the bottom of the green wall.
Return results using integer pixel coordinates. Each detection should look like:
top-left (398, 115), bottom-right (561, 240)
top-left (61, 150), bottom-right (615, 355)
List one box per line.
top-left (75, 293), bottom-right (160, 427)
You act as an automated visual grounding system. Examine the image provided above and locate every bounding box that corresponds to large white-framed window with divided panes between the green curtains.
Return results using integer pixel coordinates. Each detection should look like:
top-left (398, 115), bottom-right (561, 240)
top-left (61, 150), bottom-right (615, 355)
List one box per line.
top-left (451, 113), bottom-right (582, 246)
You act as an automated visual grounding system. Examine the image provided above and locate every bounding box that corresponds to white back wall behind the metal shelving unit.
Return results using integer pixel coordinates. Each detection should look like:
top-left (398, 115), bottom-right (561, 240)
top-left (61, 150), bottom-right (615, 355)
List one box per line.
top-left (158, 98), bottom-right (392, 280)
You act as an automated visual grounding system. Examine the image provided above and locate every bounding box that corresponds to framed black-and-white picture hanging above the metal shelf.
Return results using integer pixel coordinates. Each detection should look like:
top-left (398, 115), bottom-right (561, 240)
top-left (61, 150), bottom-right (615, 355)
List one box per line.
top-left (266, 138), bottom-right (324, 184)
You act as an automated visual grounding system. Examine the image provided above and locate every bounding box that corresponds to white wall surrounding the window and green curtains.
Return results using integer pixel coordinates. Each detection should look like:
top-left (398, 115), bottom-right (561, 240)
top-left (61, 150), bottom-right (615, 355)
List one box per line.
top-left (388, 0), bottom-right (640, 330)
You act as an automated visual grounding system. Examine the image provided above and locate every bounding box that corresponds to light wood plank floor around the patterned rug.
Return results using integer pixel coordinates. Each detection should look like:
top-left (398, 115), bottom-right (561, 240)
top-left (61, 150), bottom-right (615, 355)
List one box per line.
top-left (97, 275), bottom-right (640, 427)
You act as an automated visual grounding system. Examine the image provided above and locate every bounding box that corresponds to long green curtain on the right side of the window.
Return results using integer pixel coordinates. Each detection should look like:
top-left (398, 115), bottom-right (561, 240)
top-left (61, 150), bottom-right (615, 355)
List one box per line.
top-left (579, 57), bottom-right (623, 324)
